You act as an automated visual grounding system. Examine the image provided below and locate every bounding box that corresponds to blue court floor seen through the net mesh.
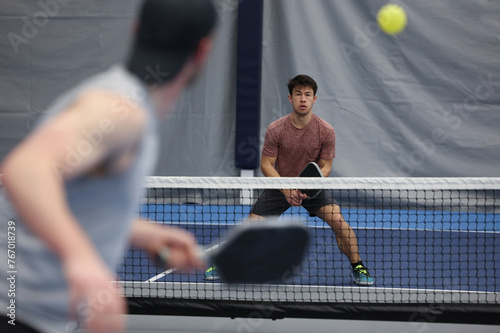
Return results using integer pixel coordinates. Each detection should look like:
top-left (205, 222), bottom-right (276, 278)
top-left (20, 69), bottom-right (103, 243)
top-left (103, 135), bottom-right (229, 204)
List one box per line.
top-left (118, 205), bottom-right (500, 292)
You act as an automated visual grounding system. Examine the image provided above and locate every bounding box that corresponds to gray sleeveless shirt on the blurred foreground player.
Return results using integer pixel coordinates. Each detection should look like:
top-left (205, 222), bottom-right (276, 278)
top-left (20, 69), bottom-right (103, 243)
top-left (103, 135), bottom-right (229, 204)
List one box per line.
top-left (0, 65), bottom-right (158, 333)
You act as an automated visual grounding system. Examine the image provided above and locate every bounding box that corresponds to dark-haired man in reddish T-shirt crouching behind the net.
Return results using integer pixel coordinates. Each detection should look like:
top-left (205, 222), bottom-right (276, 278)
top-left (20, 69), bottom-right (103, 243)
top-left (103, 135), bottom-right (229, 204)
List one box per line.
top-left (205, 75), bottom-right (373, 285)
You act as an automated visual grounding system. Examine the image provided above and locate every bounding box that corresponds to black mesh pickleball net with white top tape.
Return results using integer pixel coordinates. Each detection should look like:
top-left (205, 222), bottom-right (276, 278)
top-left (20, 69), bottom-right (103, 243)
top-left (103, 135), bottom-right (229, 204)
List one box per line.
top-left (118, 177), bottom-right (500, 323)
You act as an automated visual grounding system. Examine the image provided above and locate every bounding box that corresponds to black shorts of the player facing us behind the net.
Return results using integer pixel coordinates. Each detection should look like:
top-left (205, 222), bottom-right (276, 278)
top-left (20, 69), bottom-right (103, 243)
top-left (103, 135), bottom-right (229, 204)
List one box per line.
top-left (250, 189), bottom-right (338, 217)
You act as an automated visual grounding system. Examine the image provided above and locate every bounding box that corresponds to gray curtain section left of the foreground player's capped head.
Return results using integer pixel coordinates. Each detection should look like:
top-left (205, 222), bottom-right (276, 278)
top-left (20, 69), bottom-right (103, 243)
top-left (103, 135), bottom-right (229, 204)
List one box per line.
top-left (0, 0), bottom-right (135, 158)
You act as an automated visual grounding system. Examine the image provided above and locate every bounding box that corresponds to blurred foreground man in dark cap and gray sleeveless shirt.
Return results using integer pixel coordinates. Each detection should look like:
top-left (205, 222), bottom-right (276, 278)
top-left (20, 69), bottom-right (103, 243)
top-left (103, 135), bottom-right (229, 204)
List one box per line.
top-left (0, 0), bottom-right (217, 333)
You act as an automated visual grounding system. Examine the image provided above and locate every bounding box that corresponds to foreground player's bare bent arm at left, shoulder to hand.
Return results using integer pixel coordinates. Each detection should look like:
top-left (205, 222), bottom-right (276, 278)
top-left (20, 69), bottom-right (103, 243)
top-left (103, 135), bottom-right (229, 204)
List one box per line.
top-left (1, 92), bottom-right (145, 330)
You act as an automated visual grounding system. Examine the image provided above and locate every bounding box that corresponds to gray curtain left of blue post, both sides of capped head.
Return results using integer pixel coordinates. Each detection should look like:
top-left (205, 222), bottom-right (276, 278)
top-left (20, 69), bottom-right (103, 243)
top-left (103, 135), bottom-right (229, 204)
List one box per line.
top-left (0, 0), bottom-right (238, 176)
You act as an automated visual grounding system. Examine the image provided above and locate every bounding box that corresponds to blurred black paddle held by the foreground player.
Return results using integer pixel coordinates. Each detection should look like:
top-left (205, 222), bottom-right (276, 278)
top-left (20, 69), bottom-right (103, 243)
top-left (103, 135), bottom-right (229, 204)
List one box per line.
top-left (157, 222), bottom-right (309, 283)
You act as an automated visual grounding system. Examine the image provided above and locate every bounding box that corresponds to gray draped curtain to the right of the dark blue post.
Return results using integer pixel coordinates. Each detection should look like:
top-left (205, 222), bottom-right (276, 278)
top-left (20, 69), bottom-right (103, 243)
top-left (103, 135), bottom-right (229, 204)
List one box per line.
top-left (261, 0), bottom-right (500, 177)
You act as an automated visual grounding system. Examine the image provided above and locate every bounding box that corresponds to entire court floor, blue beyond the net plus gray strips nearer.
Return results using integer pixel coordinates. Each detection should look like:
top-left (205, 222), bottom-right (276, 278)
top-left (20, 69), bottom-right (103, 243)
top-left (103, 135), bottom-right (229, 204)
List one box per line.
top-left (118, 205), bottom-right (500, 333)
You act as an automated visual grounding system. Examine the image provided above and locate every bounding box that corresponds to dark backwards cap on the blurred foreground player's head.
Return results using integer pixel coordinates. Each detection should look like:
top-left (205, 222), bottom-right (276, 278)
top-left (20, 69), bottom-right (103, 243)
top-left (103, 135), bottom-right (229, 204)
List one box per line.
top-left (127, 0), bottom-right (217, 85)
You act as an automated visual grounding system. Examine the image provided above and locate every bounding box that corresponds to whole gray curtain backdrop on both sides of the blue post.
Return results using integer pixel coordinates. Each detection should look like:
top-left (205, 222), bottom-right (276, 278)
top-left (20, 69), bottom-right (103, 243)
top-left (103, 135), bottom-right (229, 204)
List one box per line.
top-left (0, 0), bottom-right (500, 177)
